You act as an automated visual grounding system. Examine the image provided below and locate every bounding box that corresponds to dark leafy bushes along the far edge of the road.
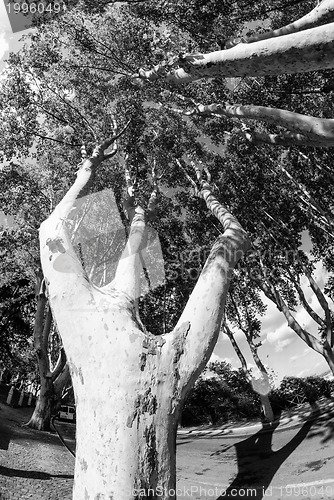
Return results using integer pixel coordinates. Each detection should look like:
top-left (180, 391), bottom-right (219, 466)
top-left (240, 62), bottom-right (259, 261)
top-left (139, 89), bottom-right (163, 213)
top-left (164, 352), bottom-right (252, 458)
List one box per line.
top-left (181, 362), bottom-right (334, 426)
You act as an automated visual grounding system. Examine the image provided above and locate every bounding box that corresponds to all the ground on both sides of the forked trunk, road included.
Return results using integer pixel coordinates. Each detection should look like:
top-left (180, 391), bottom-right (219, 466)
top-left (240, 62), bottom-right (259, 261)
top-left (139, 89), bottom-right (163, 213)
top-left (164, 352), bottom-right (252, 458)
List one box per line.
top-left (0, 400), bottom-right (334, 500)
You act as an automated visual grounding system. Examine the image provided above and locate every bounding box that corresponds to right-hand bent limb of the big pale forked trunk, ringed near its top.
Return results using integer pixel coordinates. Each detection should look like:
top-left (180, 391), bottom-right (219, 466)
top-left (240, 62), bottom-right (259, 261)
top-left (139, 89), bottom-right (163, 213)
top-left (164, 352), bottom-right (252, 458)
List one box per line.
top-left (172, 168), bottom-right (249, 398)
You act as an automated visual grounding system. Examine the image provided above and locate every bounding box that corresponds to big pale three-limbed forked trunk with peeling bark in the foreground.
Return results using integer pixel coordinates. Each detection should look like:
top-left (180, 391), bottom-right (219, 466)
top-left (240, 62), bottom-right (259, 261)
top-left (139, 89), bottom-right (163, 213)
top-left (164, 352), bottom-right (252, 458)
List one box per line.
top-left (40, 142), bottom-right (249, 500)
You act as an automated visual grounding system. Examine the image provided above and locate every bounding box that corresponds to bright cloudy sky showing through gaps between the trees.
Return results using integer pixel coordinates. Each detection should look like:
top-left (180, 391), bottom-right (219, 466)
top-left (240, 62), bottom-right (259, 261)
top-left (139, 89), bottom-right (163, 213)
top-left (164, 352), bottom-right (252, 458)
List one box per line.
top-left (0, 5), bottom-right (333, 383)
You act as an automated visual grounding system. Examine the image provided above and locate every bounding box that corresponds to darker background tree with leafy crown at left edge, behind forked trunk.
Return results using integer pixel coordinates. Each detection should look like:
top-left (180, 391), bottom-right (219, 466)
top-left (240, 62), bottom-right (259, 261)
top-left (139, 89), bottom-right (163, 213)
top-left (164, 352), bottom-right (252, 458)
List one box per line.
top-left (0, 164), bottom-right (73, 430)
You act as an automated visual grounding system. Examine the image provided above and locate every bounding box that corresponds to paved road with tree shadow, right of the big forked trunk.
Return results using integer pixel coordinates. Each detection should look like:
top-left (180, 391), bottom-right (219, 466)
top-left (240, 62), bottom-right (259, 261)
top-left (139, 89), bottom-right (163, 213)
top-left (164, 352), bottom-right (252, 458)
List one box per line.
top-left (177, 411), bottom-right (334, 500)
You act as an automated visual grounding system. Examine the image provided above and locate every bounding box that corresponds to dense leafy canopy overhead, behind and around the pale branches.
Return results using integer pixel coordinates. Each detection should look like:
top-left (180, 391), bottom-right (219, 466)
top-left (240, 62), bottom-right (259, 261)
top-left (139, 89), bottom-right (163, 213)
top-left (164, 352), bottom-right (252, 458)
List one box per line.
top-left (0, 0), bottom-right (334, 398)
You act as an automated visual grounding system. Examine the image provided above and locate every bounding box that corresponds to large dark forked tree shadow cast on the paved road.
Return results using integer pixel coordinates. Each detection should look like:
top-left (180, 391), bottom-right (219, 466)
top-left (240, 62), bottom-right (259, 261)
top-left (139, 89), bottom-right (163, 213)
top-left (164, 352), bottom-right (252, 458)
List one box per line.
top-left (216, 407), bottom-right (320, 500)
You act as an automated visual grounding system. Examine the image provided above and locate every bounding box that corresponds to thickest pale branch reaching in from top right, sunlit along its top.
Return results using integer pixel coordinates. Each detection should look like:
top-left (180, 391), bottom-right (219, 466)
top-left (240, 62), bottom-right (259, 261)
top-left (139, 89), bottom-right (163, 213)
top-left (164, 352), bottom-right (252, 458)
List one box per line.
top-left (134, 23), bottom-right (334, 84)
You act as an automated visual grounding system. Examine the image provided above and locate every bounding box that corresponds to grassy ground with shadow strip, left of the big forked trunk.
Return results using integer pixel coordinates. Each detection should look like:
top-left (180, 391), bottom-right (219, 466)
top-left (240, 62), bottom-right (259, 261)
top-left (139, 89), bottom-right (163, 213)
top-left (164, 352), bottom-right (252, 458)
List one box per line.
top-left (0, 404), bottom-right (74, 500)
